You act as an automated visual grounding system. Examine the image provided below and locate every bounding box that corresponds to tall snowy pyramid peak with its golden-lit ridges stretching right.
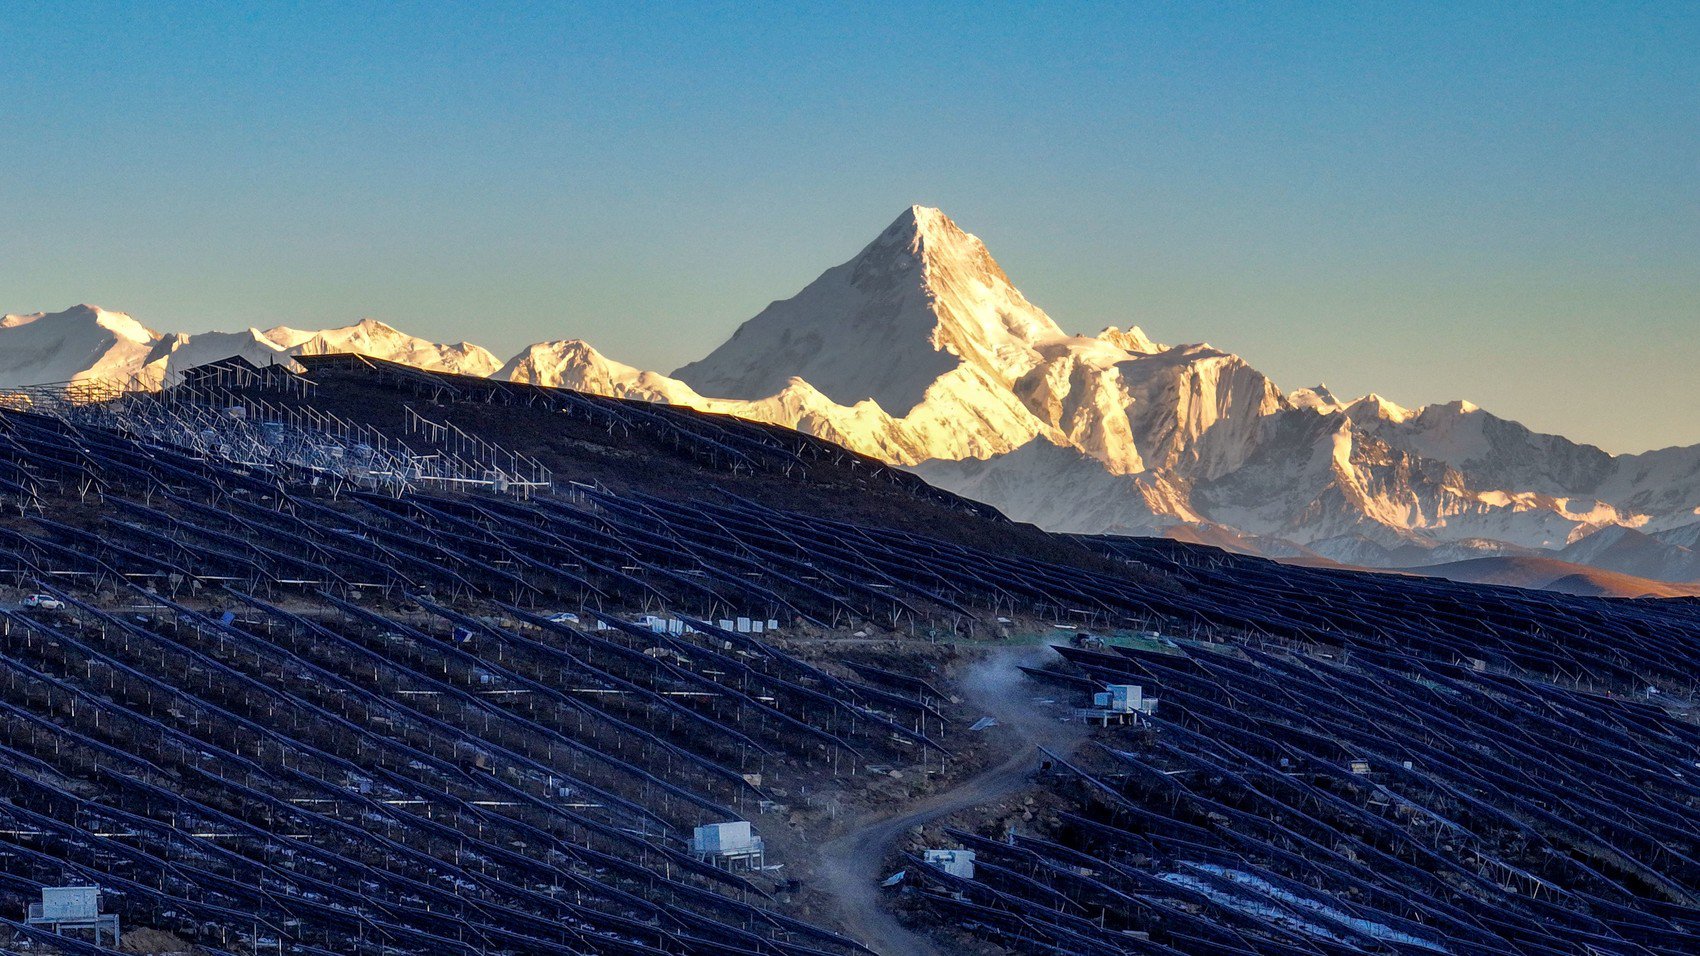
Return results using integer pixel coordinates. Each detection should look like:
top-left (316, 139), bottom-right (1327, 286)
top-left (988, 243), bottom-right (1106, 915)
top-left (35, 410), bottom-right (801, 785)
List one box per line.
top-left (508, 206), bottom-right (1700, 578)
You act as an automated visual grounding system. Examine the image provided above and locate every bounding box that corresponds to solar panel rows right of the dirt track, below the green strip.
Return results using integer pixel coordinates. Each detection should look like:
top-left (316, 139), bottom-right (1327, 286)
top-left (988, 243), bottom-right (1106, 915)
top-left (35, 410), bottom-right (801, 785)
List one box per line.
top-left (911, 632), bottom-right (1700, 956)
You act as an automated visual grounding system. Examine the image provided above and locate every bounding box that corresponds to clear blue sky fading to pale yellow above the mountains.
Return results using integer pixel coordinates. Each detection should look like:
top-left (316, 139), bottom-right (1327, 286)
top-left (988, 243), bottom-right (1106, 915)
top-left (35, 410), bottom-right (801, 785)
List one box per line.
top-left (0, 2), bottom-right (1700, 451)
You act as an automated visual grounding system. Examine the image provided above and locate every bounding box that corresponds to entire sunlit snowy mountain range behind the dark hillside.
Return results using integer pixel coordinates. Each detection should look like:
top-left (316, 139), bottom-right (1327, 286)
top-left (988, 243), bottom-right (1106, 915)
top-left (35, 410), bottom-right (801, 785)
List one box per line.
top-left (0, 206), bottom-right (1700, 594)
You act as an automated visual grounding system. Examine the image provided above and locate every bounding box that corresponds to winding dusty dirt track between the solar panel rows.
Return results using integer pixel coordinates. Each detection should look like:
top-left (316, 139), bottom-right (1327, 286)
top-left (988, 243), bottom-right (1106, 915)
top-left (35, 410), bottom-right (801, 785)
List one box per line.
top-left (818, 648), bottom-right (1083, 956)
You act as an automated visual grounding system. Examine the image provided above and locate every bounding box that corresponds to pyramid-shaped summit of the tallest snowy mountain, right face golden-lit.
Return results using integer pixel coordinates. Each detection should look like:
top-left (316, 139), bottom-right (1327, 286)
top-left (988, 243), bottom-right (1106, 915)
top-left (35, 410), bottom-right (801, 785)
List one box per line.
top-left (673, 206), bottom-right (1063, 415)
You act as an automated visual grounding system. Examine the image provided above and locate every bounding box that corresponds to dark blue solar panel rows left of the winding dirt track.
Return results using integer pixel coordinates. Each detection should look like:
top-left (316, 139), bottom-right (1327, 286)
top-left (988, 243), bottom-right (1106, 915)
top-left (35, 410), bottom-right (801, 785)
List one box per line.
top-left (0, 413), bottom-right (942, 953)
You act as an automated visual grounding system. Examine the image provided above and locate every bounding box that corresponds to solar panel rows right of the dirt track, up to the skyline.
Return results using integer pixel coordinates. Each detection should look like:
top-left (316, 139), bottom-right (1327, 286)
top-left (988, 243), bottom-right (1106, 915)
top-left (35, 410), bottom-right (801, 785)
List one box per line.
top-left (908, 539), bottom-right (1700, 956)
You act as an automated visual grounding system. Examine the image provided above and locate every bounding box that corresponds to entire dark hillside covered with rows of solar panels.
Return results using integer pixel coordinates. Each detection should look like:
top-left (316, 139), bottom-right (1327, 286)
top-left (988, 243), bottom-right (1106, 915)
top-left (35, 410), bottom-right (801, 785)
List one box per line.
top-left (0, 357), bottom-right (1700, 954)
